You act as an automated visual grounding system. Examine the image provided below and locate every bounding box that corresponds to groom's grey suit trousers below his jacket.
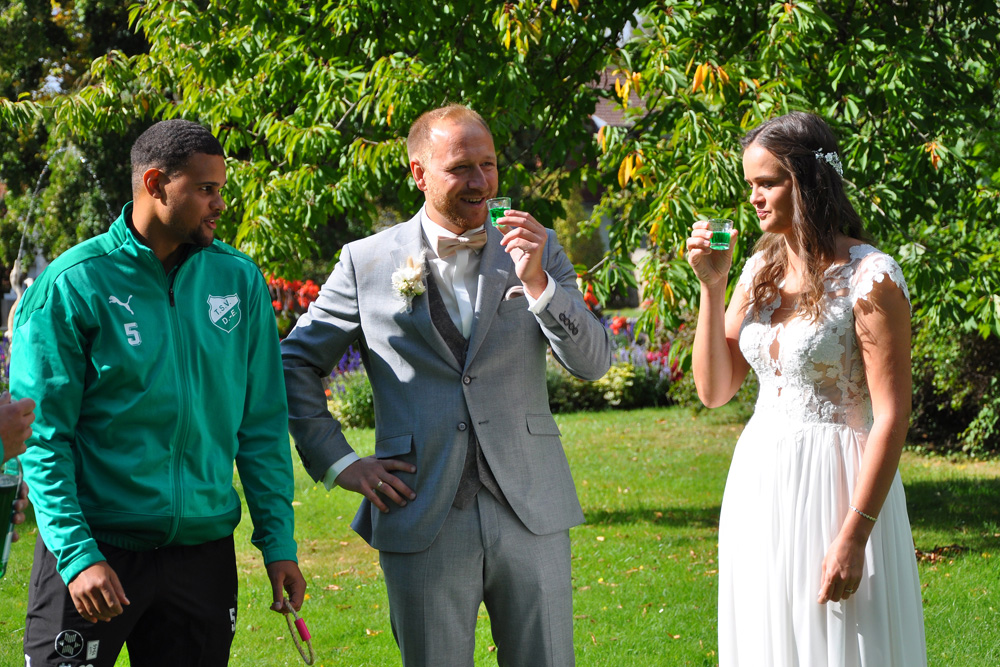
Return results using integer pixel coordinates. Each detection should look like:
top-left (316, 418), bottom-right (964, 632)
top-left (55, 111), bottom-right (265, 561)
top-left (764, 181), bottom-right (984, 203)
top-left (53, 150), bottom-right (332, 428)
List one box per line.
top-left (379, 488), bottom-right (575, 667)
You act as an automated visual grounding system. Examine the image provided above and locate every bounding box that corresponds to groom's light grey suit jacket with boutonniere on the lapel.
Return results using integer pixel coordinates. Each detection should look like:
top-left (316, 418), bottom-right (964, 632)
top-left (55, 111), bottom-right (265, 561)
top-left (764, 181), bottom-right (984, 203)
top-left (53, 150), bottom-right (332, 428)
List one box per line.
top-left (281, 214), bottom-right (611, 552)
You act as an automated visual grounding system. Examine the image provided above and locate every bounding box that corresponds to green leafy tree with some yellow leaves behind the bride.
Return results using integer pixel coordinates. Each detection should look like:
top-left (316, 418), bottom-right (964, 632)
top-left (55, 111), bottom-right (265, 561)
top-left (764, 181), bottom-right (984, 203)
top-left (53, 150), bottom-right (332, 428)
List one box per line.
top-left (584, 0), bottom-right (1000, 449)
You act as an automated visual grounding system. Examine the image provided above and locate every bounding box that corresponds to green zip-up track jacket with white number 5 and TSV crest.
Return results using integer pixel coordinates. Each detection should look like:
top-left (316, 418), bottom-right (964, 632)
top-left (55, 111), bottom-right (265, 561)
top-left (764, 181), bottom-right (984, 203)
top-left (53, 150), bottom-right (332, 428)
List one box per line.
top-left (10, 204), bottom-right (296, 584)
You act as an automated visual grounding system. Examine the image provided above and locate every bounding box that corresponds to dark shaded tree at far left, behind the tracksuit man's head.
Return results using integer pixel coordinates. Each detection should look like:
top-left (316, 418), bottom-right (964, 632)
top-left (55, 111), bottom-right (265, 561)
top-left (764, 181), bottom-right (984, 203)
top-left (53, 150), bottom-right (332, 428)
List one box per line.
top-left (0, 0), bottom-right (146, 278)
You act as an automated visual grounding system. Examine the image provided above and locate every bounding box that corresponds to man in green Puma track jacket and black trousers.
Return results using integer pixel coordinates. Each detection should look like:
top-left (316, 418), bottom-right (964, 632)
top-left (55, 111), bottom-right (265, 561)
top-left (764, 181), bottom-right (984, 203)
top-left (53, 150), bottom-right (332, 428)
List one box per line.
top-left (11, 120), bottom-right (305, 667)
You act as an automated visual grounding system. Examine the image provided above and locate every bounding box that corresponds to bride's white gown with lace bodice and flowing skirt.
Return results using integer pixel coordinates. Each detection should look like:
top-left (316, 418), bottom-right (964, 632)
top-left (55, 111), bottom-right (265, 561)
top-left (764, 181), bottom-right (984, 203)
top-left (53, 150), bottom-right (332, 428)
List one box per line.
top-left (719, 245), bottom-right (927, 667)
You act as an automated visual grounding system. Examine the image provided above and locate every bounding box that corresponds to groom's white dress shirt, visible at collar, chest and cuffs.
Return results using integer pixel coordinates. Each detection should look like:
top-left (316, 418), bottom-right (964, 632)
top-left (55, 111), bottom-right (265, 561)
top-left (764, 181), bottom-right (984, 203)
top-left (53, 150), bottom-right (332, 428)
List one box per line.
top-left (323, 208), bottom-right (556, 490)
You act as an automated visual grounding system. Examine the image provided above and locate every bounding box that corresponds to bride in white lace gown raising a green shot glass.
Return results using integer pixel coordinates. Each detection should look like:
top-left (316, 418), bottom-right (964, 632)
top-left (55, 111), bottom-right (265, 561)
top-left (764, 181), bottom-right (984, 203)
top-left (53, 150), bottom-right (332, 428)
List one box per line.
top-left (687, 112), bottom-right (927, 667)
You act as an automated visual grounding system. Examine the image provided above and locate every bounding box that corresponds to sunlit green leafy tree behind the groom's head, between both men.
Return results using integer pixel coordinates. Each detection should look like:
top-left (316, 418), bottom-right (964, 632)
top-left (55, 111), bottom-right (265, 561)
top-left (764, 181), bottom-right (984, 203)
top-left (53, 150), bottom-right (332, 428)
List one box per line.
top-left (0, 0), bottom-right (638, 270)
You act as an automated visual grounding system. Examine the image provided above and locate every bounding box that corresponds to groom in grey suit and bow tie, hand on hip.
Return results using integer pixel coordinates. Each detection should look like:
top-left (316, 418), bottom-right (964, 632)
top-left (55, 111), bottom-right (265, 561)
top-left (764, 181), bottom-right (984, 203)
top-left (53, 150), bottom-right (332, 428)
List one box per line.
top-left (282, 105), bottom-right (611, 667)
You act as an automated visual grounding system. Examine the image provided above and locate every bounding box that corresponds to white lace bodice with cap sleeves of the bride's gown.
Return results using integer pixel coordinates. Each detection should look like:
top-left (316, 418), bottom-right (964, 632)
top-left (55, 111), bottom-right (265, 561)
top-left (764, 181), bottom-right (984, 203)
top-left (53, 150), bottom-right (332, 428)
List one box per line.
top-left (740, 245), bottom-right (910, 430)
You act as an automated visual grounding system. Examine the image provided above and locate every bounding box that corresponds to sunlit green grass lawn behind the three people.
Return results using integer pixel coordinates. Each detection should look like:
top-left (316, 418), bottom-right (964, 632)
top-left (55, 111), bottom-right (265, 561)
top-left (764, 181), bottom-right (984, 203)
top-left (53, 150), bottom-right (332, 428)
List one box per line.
top-left (0, 407), bottom-right (1000, 667)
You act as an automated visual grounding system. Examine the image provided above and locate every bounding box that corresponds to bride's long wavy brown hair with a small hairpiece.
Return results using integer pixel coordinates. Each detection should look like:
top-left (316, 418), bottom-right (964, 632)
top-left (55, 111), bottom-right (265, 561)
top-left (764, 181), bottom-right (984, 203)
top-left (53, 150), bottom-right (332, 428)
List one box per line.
top-left (740, 111), bottom-right (868, 321)
